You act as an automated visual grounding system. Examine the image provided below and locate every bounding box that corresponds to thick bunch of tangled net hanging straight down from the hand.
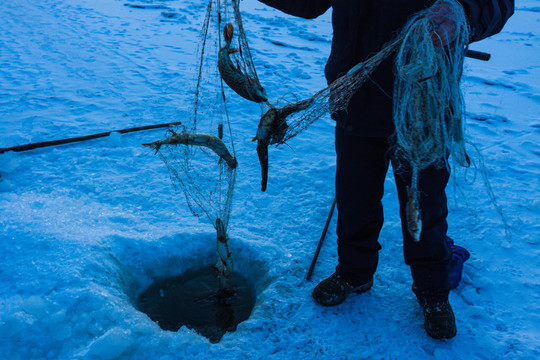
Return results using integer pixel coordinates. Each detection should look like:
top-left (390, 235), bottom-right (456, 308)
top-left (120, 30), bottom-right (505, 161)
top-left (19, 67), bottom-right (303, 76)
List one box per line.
top-left (394, 1), bottom-right (469, 180)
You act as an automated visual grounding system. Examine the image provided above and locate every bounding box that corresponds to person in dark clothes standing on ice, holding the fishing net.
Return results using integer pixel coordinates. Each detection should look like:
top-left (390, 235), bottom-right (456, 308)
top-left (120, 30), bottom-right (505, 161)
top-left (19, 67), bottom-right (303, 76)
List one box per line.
top-left (259, 0), bottom-right (514, 339)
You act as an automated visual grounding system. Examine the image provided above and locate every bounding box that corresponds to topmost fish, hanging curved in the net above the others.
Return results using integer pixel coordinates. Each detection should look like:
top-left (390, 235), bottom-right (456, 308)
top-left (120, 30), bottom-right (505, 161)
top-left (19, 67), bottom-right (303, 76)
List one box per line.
top-left (218, 23), bottom-right (268, 103)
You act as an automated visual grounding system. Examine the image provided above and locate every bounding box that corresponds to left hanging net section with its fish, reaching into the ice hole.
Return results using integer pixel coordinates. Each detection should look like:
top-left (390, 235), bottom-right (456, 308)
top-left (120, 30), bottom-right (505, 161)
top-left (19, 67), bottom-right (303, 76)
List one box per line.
top-left (145, 0), bottom-right (267, 279)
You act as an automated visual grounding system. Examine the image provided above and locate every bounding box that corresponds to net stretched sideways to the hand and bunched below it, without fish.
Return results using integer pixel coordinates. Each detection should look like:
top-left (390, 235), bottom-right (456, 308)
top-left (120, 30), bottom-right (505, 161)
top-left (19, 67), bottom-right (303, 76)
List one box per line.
top-left (268, 0), bottom-right (469, 157)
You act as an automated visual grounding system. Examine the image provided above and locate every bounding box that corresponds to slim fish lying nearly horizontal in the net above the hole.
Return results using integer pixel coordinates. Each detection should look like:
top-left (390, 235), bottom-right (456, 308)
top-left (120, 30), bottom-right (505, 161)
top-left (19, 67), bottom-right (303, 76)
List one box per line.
top-left (143, 130), bottom-right (238, 169)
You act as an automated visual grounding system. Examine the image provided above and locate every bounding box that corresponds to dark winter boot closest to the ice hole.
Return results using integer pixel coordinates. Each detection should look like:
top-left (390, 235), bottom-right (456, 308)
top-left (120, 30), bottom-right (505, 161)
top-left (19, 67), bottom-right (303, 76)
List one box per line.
top-left (312, 272), bottom-right (373, 306)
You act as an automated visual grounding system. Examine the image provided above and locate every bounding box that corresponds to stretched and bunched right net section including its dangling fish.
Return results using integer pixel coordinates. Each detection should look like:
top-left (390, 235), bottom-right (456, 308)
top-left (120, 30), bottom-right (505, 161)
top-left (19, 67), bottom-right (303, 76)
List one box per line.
top-left (255, 0), bottom-right (469, 241)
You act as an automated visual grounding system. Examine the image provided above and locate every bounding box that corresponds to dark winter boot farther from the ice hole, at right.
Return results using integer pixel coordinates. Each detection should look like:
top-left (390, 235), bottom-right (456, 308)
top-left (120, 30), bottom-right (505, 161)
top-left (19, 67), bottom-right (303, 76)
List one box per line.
top-left (417, 293), bottom-right (457, 339)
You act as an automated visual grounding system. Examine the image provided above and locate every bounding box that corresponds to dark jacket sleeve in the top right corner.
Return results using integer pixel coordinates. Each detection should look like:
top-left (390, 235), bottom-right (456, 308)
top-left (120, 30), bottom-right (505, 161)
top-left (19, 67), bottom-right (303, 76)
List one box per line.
top-left (459, 0), bottom-right (514, 42)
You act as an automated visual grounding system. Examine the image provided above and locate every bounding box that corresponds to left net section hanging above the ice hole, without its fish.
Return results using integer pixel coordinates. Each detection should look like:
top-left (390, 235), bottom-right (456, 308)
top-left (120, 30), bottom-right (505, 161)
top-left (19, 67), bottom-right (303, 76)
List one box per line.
top-left (148, 0), bottom-right (258, 231)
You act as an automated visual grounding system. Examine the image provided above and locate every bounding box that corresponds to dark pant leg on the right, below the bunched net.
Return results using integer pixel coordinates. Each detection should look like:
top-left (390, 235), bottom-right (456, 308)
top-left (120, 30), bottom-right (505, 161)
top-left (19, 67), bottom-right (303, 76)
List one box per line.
top-left (392, 160), bottom-right (452, 294)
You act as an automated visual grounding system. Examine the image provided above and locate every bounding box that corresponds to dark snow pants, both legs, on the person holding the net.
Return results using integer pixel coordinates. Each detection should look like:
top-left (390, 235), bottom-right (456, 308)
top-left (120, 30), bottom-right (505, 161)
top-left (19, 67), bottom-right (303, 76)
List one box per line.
top-left (336, 126), bottom-right (452, 294)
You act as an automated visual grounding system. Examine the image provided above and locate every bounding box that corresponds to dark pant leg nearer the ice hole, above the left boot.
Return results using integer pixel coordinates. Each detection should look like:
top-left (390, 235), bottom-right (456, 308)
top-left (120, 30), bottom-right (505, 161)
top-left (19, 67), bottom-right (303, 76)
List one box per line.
top-left (336, 127), bottom-right (388, 285)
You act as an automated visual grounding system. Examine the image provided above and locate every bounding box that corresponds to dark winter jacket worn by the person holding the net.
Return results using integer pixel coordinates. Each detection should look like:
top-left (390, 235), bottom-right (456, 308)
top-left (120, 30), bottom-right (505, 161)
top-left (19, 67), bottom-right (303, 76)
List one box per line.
top-left (260, 0), bottom-right (514, 137)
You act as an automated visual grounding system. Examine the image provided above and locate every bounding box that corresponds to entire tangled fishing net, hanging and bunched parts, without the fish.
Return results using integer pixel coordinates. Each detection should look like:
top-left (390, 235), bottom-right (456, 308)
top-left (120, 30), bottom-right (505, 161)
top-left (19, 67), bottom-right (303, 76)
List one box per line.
top-left (148, 0), bottom-right (468, 245)
